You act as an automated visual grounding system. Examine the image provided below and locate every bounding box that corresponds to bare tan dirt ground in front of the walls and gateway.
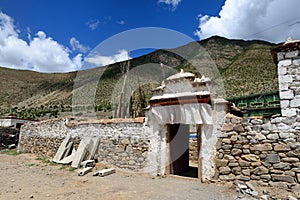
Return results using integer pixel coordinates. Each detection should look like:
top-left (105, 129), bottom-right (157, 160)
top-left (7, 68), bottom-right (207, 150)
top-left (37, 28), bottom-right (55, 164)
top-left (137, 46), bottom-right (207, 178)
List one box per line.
top-left (0, 154), bottom-right (249, 200)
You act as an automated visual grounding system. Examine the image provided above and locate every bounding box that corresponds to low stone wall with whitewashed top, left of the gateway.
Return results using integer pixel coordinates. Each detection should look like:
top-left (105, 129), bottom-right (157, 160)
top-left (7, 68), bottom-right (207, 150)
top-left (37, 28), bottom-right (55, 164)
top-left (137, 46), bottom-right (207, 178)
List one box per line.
top-left (18, 119), bottom-right (150, 171)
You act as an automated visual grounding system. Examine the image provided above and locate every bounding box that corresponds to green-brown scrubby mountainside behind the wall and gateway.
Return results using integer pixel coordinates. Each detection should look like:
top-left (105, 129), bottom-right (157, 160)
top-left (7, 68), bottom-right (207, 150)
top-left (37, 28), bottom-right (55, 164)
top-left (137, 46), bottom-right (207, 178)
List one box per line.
top-left (0, 36), bottom-right (278, 119)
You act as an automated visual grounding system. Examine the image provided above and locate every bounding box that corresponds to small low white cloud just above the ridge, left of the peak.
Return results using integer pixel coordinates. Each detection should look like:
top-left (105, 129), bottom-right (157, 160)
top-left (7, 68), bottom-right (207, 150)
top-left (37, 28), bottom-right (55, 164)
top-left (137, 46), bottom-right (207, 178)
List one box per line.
top-left (85, 49), bottom-right (130, 67)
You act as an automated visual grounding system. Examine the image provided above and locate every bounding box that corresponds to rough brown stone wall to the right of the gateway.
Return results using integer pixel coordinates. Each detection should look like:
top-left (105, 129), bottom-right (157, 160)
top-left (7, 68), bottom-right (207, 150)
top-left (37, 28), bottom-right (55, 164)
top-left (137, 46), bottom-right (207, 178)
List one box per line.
top-left (216, 114), bottom-right (300, 186)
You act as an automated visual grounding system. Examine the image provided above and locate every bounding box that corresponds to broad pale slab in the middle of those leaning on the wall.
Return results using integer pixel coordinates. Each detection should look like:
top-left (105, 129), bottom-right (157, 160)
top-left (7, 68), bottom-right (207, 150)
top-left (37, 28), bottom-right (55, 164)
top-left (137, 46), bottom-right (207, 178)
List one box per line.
top-left (71, 137), bottom-right (92, 168)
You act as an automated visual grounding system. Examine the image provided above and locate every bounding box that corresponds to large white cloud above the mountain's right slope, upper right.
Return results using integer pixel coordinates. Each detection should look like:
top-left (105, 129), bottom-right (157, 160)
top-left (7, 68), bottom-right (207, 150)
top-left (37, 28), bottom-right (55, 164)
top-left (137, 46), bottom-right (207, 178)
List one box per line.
top-left (195, 0), bottom-right (300, 43)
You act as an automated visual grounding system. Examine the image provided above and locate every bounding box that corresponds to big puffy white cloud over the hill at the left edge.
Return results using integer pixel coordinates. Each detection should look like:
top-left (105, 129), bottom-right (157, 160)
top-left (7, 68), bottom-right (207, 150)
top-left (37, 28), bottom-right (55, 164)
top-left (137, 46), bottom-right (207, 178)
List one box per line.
top-left (0, 12), bottom-right (83, 72)
